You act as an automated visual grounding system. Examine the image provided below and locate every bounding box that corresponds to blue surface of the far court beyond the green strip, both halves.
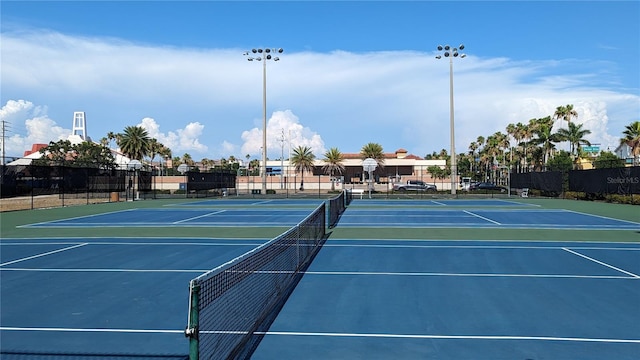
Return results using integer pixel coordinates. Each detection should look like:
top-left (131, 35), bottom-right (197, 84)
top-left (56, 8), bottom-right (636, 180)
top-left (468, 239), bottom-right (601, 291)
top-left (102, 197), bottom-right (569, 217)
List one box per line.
top-left (16, 200), bottom-right (640, 230)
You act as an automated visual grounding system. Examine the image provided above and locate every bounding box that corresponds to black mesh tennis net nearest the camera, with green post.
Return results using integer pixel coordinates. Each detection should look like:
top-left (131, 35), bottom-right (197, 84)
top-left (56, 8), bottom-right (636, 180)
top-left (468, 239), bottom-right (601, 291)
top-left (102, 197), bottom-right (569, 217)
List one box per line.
top-left (185, 203), bottom-right (326, 359)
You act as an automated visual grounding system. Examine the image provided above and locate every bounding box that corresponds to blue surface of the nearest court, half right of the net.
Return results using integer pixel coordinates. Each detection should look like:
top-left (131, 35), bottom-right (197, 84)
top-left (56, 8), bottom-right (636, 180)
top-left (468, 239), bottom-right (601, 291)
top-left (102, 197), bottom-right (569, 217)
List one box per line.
top-left (252, 240), bottom-right (640, 360)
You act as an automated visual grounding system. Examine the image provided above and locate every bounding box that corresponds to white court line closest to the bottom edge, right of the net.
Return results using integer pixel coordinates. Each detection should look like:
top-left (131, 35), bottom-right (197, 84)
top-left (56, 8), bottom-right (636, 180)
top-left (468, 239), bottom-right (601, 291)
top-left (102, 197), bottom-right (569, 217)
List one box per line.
top-left (200, 330), bottom-right (640, 344)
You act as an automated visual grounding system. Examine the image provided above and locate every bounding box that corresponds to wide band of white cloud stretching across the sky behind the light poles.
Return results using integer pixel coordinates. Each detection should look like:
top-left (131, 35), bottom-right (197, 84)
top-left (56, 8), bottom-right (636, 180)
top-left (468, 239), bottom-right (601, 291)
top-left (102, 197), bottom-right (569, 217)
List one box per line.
top-left (0, 28), bottom-right (640, 159)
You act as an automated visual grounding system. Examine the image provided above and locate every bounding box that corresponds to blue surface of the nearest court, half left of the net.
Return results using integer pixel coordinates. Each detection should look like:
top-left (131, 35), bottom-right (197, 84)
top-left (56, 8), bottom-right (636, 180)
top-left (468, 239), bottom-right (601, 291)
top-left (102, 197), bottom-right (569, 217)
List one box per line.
top-left (0, 238), bottom-right (267, 355)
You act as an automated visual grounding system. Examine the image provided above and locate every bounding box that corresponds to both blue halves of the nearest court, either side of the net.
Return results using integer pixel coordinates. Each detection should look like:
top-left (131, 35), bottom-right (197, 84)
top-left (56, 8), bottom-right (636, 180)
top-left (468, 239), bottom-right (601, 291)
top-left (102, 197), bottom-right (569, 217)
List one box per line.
top-left (0, 238), bottom-right (640, 359)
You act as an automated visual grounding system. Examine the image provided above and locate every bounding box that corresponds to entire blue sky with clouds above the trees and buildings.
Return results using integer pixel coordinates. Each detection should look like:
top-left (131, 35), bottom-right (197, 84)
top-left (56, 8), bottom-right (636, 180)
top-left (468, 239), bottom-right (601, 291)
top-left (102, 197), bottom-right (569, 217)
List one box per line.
top-left (0, 0), bottom-right (640, 163)
